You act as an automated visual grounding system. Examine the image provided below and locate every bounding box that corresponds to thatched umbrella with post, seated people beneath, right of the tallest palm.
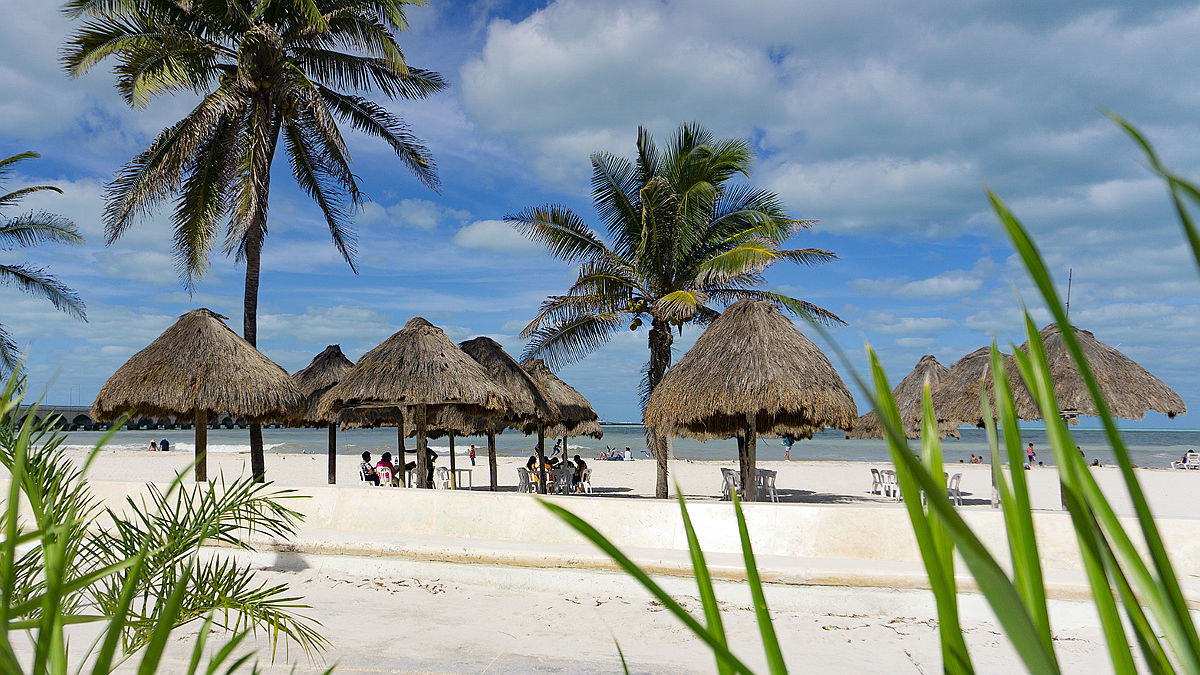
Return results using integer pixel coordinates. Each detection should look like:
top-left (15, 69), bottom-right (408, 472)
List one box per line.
top-left (318, 317), bottom-right (511, 486)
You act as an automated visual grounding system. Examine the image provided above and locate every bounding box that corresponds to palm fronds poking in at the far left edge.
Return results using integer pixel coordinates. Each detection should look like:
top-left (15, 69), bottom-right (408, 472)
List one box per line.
top-left (0, 153), bottom-right (88, 375)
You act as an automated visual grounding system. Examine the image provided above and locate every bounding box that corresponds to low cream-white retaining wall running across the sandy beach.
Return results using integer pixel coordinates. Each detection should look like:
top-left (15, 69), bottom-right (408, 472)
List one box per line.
top-left (72, 482), bottom-right (1200, 578)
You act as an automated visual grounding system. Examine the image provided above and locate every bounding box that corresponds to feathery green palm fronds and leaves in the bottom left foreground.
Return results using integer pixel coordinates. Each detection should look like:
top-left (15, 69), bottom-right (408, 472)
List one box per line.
top-left (0, 376), bottom-right (328, 675)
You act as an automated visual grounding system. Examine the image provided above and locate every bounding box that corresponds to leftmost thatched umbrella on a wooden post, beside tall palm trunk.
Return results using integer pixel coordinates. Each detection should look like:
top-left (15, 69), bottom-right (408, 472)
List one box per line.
top-left (91, 309), bottom-right (302, 482)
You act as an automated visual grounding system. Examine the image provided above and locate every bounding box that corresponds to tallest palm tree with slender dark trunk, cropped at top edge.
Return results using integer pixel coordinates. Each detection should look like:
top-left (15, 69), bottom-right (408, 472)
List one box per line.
top-left (64, 0), bottom-right (445, 479)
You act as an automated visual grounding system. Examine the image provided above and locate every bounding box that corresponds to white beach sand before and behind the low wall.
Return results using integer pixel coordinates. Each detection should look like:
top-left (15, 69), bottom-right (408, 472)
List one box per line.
top-left (23, 450), bottom-right (1200, 673)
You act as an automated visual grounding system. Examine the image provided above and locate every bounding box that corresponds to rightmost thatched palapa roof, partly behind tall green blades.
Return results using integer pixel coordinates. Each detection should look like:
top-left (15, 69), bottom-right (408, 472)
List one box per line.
top-left (1015, 323), bottom-right (1188, 419)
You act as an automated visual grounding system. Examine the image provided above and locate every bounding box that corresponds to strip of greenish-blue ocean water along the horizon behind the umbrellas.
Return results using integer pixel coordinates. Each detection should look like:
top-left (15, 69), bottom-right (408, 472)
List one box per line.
top-left (58, 424), bottom-right (1200, 467)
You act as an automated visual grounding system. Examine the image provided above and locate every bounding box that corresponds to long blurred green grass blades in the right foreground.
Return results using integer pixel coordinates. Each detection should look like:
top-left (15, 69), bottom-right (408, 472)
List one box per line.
top-left (545, 114), bottom-right (1200, 674)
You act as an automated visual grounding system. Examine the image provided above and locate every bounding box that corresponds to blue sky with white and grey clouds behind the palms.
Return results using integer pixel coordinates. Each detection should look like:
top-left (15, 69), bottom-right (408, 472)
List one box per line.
top-left (0, 0), bottom-right (1200, 428)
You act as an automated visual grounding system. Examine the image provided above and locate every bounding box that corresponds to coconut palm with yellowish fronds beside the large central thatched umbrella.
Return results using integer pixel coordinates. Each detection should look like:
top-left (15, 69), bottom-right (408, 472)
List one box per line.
top-left (506, 124), bottom-right (841, 497)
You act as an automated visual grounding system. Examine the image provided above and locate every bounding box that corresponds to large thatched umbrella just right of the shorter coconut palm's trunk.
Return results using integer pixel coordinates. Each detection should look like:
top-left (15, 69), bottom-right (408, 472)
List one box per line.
top-left (644, 300), bottom-right (858, 501)
